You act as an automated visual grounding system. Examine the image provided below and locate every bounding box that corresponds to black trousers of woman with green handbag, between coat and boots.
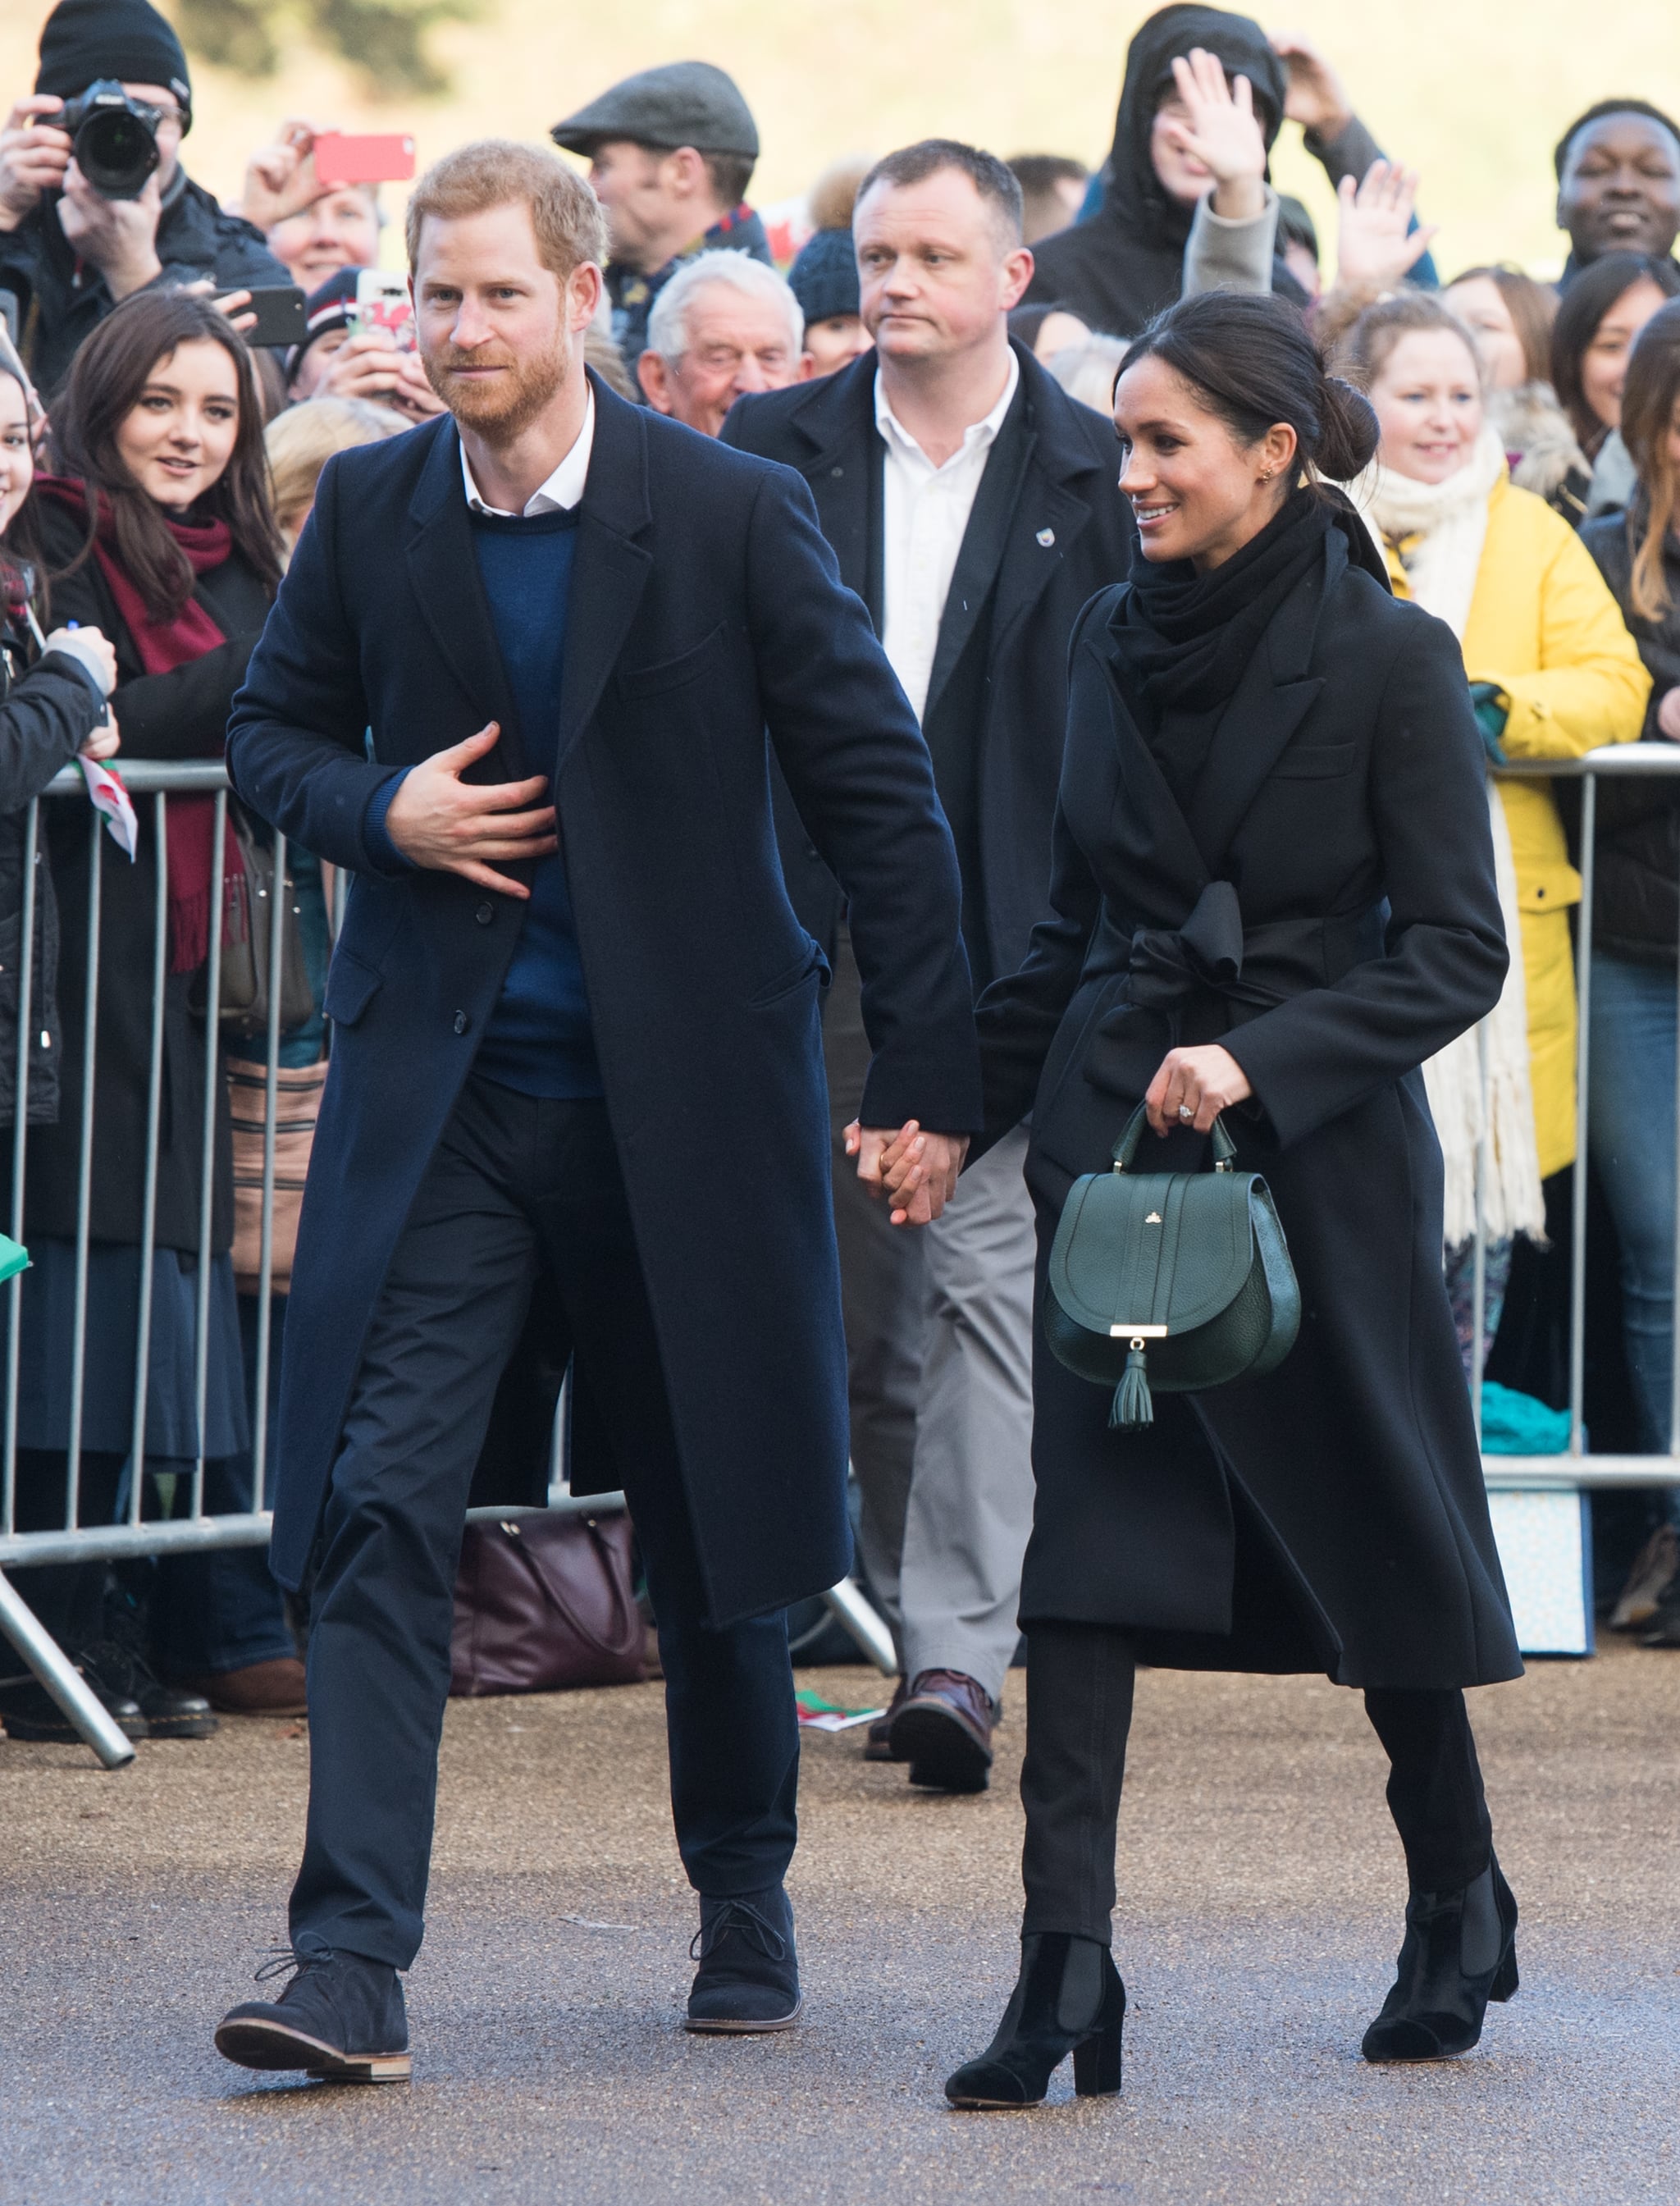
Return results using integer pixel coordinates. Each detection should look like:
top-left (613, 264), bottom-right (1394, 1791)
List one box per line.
top-left (1020, 1624), bottom-right (1493, 1946)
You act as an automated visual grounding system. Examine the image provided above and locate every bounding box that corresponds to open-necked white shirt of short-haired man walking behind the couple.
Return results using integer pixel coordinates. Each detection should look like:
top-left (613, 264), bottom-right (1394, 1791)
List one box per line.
top-left (875, 346), bottom-right (1020, 719)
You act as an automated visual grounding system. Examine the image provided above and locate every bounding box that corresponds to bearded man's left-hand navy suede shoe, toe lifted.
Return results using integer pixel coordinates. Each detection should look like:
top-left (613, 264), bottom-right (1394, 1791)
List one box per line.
top-left (216, 1953), bottom-right (410, 2082)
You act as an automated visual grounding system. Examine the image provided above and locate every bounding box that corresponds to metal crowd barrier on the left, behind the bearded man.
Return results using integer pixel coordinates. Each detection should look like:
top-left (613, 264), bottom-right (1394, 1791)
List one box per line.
top-left (0, 759), bottom-right (897, 1770)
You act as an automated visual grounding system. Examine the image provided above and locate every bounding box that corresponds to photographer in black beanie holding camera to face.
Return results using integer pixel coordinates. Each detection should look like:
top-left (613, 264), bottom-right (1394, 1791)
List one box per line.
top-left (0, 0), bottom-right (289, 400)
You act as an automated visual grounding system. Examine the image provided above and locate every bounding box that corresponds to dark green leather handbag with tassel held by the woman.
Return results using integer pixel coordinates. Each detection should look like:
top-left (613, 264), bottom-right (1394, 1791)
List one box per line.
top-left (1045, 1103), bottom-right (1301, 1427)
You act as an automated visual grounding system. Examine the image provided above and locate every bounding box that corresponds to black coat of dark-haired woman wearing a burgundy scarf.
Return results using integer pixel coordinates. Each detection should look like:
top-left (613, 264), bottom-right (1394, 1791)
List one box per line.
top-left (10, 505), bottom-right (269, 1255)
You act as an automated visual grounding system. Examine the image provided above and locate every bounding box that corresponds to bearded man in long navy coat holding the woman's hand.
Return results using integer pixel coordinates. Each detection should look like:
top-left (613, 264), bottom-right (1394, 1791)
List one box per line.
top-left (216, 141), bottom-right (981, 2080)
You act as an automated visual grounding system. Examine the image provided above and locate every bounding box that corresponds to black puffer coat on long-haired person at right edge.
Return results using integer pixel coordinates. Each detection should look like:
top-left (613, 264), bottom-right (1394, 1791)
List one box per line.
top-left (1581, 503), bottom-right (1680, 964)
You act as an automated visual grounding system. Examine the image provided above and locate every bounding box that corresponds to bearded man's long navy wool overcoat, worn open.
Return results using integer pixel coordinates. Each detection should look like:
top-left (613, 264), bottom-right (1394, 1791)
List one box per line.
top-left (230, 381), bottom-right (979, 1621)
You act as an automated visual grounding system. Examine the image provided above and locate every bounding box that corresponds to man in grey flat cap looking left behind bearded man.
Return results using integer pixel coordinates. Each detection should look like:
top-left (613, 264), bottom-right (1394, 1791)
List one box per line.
top-left (549, 62), bottom-right (769, 375)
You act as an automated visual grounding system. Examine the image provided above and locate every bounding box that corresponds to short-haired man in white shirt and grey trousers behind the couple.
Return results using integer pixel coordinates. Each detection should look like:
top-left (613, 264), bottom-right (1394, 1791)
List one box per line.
top-left (724, 139), bottom-right (1133, 1791)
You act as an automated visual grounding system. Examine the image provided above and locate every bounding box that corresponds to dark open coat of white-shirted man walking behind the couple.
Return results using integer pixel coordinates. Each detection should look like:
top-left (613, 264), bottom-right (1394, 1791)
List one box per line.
top-left (724, 344), bottom-right (1138, 973)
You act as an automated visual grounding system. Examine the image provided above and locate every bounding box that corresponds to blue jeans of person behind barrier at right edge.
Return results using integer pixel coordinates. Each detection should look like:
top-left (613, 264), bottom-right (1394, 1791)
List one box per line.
top-left (1587, 953), bottom-right (1676, 1456)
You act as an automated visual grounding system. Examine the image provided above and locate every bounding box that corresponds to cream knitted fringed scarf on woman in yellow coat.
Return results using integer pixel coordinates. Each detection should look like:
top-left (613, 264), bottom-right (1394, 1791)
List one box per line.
top-left (1347, 428), bottom-right (1545, 1249)
